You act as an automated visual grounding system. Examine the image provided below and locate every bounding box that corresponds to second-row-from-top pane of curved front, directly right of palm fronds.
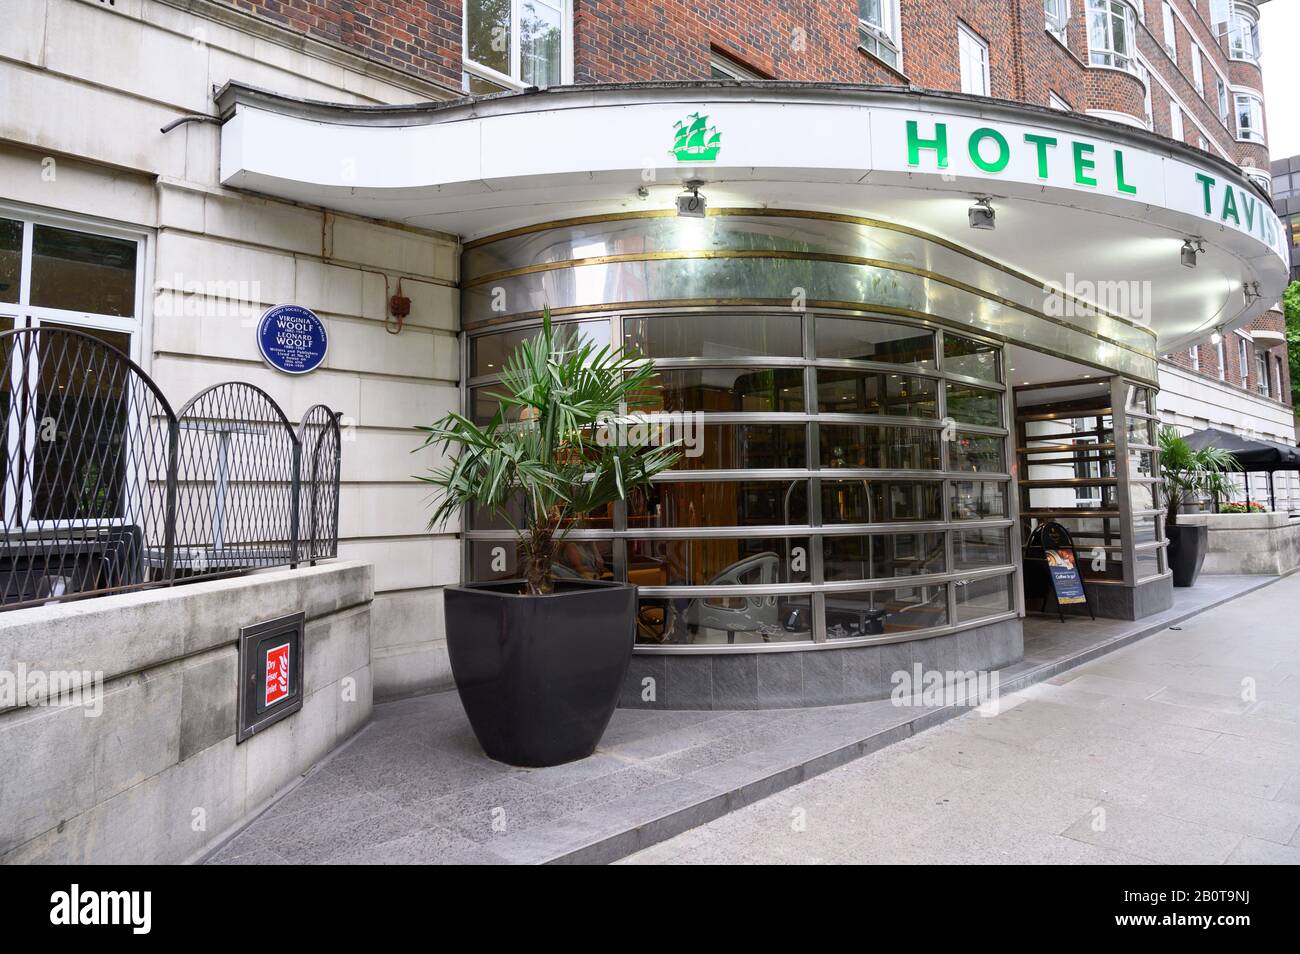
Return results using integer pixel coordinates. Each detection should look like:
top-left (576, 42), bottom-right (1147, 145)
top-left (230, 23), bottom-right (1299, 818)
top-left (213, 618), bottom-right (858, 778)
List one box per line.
top-left (631, 368), bottom-right (803, 413)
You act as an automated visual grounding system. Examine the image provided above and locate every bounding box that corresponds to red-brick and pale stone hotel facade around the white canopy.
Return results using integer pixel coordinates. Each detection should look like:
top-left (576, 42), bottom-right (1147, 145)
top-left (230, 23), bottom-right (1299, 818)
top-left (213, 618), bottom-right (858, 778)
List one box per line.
top-left (0, 0), bottom-right (1295, 697)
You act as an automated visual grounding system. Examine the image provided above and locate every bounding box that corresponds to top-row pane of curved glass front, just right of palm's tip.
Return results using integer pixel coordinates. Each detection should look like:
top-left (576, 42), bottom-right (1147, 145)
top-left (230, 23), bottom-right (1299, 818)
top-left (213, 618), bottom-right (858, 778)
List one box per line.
top-left (623, 315), bottom-right (803, 357)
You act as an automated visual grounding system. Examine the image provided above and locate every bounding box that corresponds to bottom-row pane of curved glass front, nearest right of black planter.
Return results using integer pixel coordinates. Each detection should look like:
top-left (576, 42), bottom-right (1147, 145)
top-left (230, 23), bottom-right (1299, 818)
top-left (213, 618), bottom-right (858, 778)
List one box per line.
top-left (637, 595), bottom-right (813, 645)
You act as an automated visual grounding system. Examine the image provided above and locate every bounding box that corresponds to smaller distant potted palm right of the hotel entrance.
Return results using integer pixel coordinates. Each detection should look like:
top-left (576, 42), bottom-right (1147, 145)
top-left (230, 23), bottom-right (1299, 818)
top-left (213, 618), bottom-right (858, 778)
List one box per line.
top-left (1160, 428), bottom-right (1240, 586)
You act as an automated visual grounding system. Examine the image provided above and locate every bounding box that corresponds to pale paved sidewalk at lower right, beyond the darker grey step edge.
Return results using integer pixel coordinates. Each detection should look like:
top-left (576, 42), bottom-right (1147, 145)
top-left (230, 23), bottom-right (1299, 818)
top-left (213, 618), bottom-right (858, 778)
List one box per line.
top-left (628, 576), bottom-right (1300, 864)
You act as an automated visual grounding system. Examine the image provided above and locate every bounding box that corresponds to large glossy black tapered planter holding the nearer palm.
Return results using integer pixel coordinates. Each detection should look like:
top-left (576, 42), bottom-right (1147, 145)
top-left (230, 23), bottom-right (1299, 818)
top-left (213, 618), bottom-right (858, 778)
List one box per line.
top-left (446, 580), bottom-right (637, 766)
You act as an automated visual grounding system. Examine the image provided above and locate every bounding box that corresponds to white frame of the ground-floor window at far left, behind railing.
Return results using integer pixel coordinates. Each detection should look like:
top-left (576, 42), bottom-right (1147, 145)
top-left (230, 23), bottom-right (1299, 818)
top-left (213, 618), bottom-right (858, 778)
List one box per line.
top-left (0, 203), bottom-right (148, 528)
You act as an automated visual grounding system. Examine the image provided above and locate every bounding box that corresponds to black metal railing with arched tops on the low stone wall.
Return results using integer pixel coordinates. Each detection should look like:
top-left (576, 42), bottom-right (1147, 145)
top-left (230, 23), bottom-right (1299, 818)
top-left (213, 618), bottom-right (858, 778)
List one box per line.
top-left (0, 326), bottom-right (342, 610)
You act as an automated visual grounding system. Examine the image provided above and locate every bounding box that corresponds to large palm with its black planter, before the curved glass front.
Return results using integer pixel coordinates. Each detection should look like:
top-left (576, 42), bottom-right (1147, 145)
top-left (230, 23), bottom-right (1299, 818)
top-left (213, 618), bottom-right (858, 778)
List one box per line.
top-left (420, 309), bottom-right (677, 766)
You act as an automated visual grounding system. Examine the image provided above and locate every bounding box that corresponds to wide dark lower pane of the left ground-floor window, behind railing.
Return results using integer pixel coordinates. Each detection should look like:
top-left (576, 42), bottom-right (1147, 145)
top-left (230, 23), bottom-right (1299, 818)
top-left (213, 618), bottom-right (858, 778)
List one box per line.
top-left (31, 328), bottom-right (131, 520)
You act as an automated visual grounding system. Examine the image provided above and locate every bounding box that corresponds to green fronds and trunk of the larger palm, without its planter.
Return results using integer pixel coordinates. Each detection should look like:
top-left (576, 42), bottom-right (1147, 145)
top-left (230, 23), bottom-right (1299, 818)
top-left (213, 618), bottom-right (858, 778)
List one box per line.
top-left (417, 314), bottom-right (677, 595)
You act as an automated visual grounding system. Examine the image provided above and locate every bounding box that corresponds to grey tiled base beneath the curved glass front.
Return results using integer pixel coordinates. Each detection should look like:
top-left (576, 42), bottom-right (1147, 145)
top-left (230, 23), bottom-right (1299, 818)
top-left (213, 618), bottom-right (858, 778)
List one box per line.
top-left (619, 620), bottom-right (1024, 708)
